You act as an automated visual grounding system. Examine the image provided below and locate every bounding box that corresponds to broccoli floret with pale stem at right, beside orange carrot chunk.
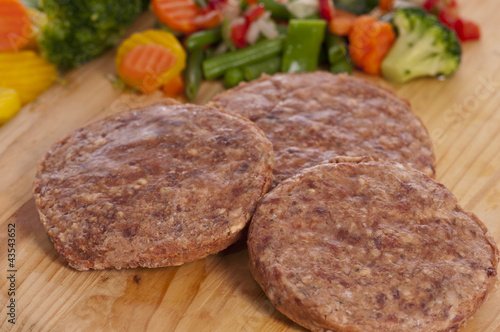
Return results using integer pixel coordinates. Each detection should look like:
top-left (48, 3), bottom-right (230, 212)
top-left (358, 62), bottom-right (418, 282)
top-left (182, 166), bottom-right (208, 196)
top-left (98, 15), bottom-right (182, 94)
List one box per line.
top-left (382, 8), bottom-right (462, 83)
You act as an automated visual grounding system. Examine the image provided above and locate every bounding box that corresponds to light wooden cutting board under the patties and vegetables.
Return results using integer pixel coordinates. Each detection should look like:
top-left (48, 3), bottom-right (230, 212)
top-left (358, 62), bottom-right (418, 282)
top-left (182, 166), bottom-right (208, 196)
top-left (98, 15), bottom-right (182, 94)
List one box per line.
top-left (0, 0), bottom-right (500, 332)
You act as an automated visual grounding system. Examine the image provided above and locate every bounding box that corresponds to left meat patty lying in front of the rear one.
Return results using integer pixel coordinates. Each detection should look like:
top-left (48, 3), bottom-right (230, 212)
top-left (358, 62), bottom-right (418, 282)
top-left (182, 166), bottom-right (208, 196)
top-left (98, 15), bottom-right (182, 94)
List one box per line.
top-left (34, 103), bottom-right (273, 270)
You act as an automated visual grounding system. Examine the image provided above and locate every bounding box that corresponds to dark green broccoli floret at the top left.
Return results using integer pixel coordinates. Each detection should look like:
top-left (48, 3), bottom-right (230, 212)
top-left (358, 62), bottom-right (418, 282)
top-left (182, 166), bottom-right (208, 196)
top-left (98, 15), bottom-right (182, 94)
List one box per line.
top-left (39, 0), bottom-right (145, 69)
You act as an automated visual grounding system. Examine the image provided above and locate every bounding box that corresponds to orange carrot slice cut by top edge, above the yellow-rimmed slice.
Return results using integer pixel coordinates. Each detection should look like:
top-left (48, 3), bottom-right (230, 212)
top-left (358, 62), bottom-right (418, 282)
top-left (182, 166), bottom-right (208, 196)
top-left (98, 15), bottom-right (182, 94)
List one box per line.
top-left (152, 0), bottom-right (200, 34)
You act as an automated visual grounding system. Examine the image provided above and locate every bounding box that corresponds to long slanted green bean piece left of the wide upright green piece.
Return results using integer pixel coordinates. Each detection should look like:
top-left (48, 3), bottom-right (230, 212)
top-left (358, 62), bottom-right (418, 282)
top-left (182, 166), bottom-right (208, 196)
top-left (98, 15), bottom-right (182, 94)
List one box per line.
top-left (202, 37), bottom-right (284, 80)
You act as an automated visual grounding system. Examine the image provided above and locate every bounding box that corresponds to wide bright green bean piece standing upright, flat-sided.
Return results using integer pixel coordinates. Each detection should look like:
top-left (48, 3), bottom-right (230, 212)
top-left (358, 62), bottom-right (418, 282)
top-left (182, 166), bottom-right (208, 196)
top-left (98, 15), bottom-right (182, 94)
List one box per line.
top-left (281, 20), bottom-right (326, 73)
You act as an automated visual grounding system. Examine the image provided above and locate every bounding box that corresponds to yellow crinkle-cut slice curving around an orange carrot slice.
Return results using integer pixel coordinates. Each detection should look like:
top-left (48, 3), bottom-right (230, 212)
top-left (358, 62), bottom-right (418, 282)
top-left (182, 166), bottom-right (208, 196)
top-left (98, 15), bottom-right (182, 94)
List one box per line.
top-left (115, 30), bottom-right (186, 86)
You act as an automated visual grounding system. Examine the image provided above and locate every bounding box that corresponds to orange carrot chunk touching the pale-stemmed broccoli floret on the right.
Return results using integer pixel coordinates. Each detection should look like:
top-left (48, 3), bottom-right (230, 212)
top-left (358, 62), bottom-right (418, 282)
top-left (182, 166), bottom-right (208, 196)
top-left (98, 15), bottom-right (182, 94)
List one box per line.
top-left (349, 15), bottom-right (396, 75)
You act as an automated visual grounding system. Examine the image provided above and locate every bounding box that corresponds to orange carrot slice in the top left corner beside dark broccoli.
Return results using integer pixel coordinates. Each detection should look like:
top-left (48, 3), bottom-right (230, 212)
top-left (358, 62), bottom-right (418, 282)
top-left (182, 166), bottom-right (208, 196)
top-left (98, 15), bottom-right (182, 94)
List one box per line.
top-left (0, 0), bottom-right (32, 52)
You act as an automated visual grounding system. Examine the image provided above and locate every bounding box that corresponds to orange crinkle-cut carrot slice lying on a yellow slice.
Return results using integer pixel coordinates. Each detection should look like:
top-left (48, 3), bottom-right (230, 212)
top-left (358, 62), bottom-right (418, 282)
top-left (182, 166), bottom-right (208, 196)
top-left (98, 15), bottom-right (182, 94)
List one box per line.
top-left (119, 44), bottom-right (177, 93)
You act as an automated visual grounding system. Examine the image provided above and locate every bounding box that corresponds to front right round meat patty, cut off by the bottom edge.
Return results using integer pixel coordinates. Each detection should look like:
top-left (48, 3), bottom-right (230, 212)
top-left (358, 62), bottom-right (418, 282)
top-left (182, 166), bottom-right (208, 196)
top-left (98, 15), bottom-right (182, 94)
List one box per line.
top-left (248, 158), bottom-right (498, 332)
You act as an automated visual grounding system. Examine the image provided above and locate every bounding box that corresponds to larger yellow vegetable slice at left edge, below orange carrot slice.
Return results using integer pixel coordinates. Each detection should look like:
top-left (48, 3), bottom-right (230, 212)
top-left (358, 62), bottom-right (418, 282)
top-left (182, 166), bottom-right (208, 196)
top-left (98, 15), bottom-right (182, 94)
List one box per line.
top-left (0, 51), bottom-right (58, 105)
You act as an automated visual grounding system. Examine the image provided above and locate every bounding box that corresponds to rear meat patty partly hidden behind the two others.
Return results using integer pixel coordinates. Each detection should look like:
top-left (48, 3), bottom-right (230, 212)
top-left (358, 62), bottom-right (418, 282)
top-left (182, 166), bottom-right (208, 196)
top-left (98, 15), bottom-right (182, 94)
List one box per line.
top-left (212, 72), bottom-right (435, 183)
